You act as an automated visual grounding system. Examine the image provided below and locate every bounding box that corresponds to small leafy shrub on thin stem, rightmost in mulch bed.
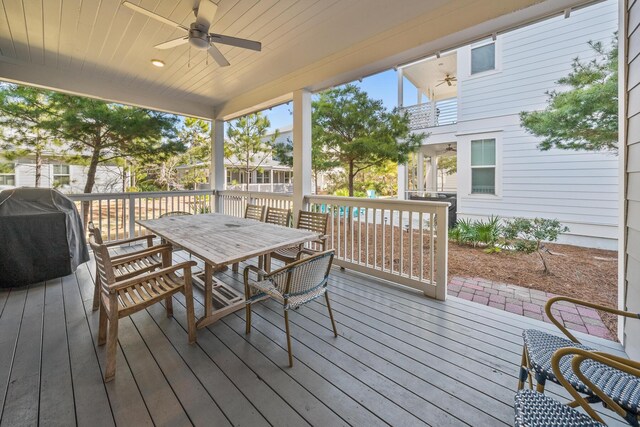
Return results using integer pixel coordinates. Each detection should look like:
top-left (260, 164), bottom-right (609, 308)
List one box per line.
top-left (503, 218), bottom-right (569, 273)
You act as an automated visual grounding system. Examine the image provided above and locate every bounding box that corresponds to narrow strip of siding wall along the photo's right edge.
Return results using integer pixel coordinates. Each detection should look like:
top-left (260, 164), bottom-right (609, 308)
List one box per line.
top-left (621, 0), bottom-right (640, 360)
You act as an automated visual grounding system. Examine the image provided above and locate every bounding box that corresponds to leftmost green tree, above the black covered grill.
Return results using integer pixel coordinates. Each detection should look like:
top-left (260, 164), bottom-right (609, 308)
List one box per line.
top-left (0, 83), bottom-right (56, 187)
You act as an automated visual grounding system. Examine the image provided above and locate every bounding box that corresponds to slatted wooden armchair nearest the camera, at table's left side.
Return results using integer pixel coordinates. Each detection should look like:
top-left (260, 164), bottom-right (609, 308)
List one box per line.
top-left (89, 236), bottom-right (196, 382)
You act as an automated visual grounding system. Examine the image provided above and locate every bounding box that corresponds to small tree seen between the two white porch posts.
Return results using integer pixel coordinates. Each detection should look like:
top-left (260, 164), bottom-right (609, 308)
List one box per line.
top-left (224, 112), bottom-right (278, 189)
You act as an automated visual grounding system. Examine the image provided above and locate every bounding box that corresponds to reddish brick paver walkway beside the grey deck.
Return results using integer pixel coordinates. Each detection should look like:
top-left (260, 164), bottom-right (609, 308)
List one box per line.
top-left (448, 276), bottom-right (613, 340)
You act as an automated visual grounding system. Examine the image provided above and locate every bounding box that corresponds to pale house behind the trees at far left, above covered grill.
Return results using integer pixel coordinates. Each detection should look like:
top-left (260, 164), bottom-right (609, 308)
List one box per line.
top-left (0, 158), bottom-right (128, 194)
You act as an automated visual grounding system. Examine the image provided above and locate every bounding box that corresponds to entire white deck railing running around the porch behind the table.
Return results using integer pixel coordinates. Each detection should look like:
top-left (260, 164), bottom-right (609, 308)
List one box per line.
top-left (70, 190), bottom-right (449, 299)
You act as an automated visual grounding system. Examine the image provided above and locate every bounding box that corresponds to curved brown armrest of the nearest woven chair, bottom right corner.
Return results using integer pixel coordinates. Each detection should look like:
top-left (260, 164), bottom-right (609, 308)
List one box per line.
top-left (551, 347), bottom-right (640, 424)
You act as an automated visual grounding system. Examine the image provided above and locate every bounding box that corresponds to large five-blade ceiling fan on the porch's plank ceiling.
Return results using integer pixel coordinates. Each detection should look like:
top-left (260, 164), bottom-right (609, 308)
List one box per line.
top-left (122, 0), bottom-right (262, 67)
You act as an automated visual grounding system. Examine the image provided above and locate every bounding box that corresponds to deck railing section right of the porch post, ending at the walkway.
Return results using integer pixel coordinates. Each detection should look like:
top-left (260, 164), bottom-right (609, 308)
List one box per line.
top-left (306, 196), bottom-right (449, 299)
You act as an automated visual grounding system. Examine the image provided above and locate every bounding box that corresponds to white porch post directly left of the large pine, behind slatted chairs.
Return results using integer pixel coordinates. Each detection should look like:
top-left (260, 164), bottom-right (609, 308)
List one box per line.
top-left (293, 89), bottom-right (311, 221)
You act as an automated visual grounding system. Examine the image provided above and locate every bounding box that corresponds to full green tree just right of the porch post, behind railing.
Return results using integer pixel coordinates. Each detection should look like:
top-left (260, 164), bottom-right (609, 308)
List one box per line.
top-left (313, 84), bottom-right (424, 196)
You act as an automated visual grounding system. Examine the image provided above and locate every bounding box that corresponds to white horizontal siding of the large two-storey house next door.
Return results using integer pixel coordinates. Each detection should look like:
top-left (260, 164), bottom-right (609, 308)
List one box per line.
top-left (456, 0), bottom-right (619, 249)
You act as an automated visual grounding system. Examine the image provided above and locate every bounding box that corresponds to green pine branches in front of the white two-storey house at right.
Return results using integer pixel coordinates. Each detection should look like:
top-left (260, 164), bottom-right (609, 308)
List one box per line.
top-left (520, 37), bottom-right (618, 152)
